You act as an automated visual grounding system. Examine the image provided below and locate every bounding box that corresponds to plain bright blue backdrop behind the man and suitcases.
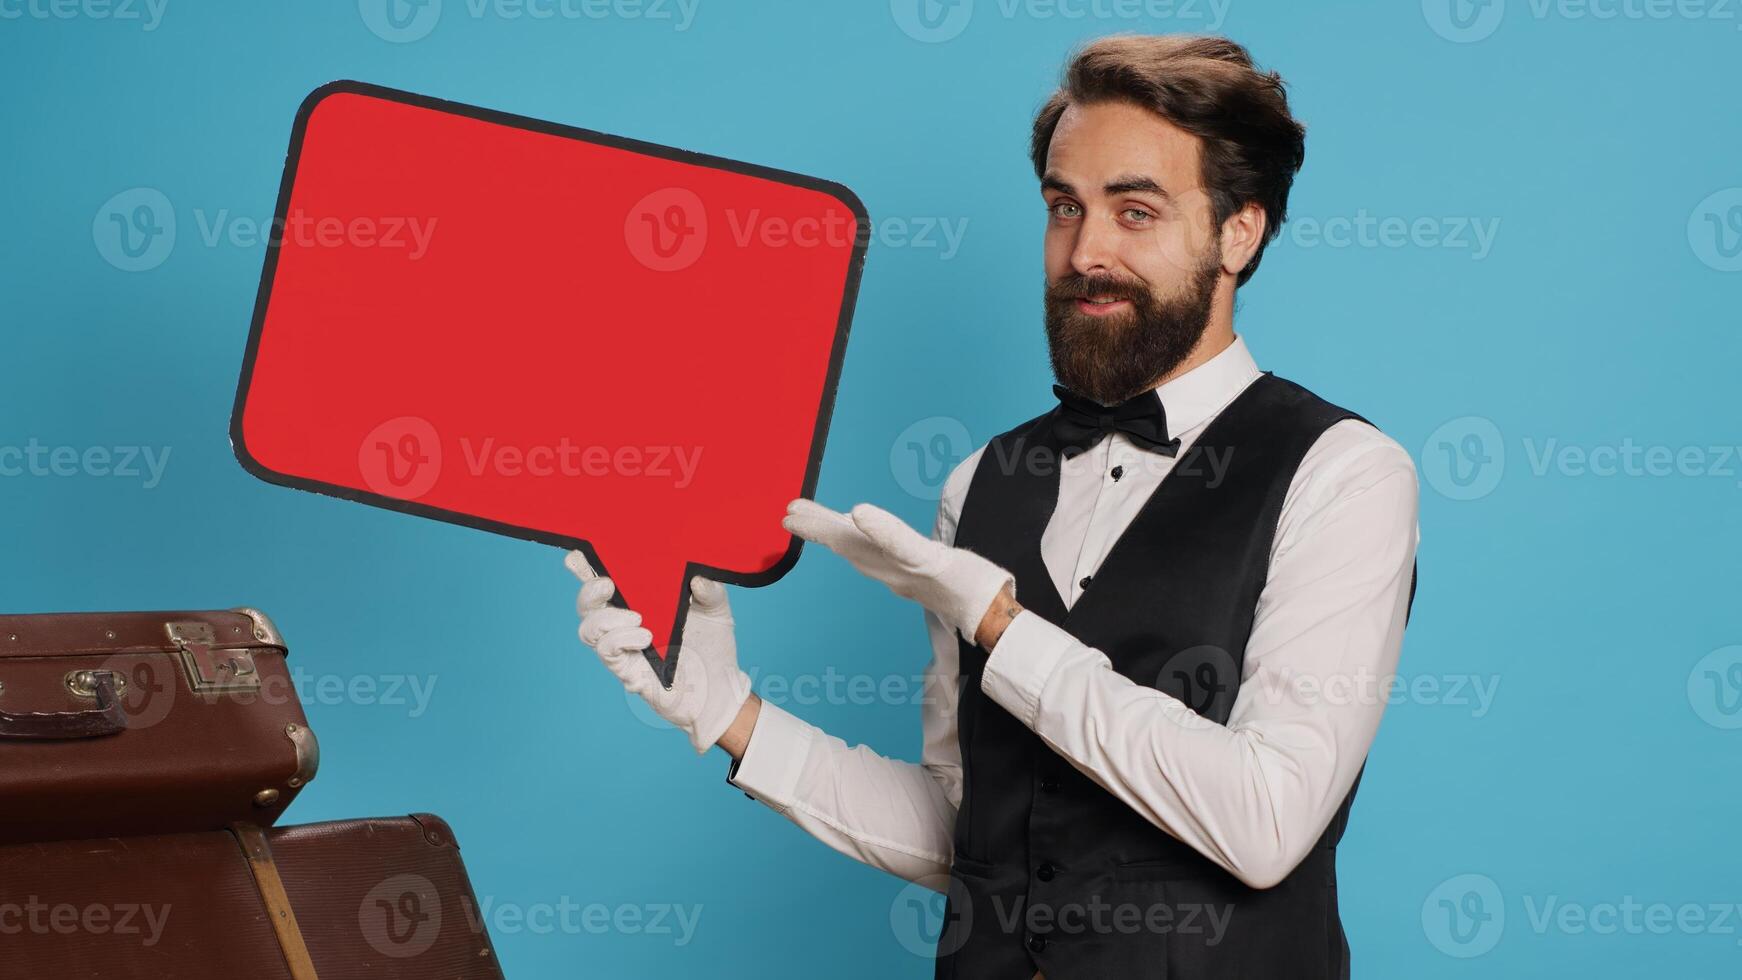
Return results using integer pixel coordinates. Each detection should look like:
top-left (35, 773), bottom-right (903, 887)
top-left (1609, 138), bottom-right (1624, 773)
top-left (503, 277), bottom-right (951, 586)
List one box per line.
top-left (0, 0), bottom-right (1742, 978)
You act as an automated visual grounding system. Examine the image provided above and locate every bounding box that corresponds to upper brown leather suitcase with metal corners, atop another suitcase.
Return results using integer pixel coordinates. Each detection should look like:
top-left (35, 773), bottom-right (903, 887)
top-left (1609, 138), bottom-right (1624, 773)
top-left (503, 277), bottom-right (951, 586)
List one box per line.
top-left (0, 609), bottom-right (321, 844)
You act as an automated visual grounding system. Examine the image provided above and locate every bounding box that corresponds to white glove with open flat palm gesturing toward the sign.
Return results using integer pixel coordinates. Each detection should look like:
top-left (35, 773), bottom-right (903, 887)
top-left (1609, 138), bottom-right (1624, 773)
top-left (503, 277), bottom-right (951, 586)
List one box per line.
top-left (783, 498), bottom-right (1016, 644)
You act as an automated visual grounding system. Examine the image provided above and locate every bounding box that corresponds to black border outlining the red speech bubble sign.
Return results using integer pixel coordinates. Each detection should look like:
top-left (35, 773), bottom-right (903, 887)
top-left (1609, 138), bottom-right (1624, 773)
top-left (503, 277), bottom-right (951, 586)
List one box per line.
top-left (230, 80), bottom-right (871, 688)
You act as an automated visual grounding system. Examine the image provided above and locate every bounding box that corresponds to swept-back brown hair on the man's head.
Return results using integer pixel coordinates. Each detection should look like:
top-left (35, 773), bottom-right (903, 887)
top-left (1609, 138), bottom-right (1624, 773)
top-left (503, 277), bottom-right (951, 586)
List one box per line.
top-left (1028, 35), bottom-right (1307, 285)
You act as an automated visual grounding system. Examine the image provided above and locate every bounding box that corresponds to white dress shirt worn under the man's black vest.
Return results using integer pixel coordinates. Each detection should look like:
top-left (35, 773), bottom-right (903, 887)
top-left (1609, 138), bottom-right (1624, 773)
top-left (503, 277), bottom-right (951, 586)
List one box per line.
top-left (730, 336), bottom-right (1420, 889)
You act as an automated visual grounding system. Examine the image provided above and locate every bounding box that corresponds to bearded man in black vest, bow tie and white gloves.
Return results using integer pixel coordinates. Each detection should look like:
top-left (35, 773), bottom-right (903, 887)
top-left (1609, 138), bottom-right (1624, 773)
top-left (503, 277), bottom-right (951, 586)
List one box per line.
top-left (570, 37), bottom-right (1420, 980)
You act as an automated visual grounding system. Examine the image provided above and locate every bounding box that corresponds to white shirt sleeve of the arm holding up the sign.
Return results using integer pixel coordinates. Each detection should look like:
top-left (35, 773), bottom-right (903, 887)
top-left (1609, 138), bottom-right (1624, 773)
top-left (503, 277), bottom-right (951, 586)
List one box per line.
top-left (726, 451), bottom-right (981, 891)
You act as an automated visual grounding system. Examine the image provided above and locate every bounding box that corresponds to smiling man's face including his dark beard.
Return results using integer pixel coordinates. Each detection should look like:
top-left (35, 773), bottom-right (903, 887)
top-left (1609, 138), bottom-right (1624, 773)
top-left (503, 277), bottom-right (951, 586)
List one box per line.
top-left (1040, 103), bottom-right (1221, 404)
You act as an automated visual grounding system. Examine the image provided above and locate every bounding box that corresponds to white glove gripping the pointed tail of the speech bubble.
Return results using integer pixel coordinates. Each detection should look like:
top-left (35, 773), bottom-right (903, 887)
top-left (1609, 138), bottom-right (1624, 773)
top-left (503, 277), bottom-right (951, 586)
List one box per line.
top-left (564, 552), bottom-right (751, 754)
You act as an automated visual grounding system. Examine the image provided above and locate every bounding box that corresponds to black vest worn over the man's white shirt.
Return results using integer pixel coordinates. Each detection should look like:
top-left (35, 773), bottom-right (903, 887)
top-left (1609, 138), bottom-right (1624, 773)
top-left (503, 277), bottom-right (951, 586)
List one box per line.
top-left (935, 373), bottom-right (1415, 980)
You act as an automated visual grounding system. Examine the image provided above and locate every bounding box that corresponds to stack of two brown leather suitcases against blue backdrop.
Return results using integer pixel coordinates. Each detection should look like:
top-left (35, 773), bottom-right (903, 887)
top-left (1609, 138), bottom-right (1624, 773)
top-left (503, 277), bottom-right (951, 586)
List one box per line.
top-left (0, 609), bottom-right (502, 980)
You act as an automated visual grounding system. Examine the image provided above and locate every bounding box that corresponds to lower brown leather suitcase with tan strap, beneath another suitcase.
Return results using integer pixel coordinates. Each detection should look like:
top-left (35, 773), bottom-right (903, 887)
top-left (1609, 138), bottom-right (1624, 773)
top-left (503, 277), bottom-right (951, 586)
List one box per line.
top-left (0, 813), bottom-right (502, 980)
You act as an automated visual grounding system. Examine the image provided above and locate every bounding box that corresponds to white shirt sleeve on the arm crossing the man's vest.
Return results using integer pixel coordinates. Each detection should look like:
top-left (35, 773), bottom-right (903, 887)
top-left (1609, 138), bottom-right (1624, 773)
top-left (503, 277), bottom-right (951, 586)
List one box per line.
top-left (981, 420), bottom-right (1420, 888)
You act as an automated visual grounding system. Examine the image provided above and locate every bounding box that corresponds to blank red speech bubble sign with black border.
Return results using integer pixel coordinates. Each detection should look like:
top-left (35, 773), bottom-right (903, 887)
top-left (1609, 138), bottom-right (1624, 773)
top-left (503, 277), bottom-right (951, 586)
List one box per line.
top-left (232, 82), bottom-right (869, 686)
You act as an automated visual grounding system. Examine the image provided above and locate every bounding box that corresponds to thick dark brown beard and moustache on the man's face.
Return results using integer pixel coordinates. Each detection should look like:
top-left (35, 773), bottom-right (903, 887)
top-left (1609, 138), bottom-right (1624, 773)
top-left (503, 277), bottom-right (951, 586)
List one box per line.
top-left (1045, 242), bottom-right (1221, 406)
